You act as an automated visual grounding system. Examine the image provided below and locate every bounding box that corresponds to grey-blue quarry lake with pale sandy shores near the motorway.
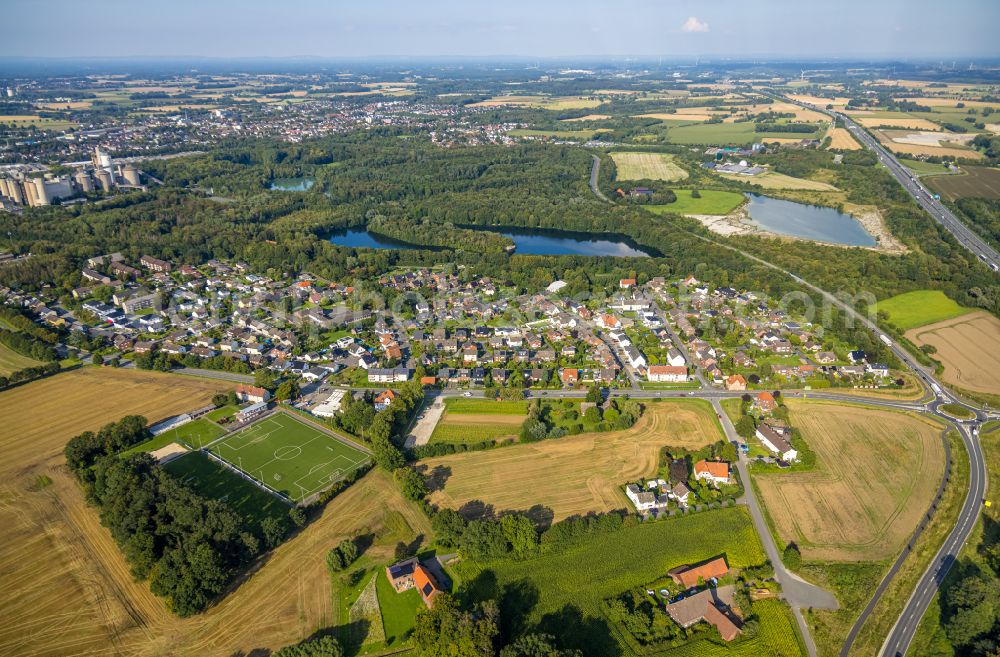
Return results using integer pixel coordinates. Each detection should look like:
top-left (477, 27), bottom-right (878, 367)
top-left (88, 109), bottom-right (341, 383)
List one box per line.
top-left (747, 194), bottom-right (877, 246)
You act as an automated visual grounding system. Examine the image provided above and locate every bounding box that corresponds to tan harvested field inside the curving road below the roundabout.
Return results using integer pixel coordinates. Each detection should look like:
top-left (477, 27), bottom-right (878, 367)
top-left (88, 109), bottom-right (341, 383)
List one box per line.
top-left (754, 400), bottom-right (944, 561)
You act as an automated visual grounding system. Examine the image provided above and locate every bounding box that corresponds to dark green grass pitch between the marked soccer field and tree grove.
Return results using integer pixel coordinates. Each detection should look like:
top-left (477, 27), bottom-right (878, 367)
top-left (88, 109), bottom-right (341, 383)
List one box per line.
top-left (163, 452), bottom-right (288, 525)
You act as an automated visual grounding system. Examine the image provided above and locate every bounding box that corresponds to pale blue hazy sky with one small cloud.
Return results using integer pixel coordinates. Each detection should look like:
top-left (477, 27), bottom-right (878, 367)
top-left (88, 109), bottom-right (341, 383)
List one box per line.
top-left (0, 0), bottom-right (1000, 59)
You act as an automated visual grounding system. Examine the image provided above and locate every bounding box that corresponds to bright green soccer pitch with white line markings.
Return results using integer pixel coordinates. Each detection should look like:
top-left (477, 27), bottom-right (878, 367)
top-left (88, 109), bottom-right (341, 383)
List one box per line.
top-left (208, 413), bottom-right (368, 502)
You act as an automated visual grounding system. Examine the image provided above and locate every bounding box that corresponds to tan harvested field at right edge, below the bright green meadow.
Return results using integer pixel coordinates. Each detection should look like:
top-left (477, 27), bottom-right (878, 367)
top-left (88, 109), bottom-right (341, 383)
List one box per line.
top-left (906, 311), bottom-right (1000, 395)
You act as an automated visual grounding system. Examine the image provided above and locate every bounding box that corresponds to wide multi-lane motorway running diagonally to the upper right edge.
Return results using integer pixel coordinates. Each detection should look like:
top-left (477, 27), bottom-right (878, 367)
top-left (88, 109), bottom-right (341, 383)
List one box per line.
top-left (782, 91), bottom-right (1000, 271)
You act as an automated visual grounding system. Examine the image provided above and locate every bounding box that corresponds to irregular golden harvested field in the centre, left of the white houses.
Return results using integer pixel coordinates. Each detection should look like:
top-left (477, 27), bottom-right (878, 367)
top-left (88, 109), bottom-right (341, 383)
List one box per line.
top-left (423, 399), bottom-right (723, 520)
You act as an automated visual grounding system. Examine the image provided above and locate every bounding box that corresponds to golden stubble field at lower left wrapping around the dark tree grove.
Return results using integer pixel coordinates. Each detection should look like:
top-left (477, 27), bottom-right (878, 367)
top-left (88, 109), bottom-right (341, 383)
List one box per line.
top-left (0, 369), bottom-right (430, 657)
